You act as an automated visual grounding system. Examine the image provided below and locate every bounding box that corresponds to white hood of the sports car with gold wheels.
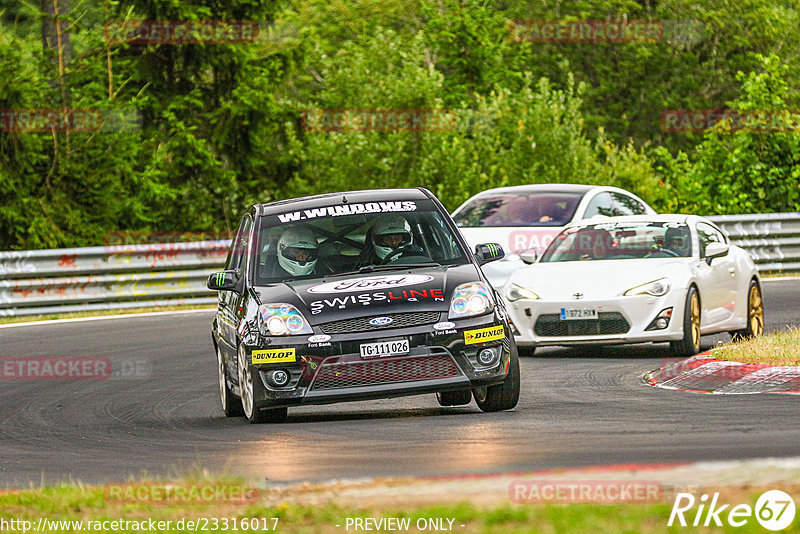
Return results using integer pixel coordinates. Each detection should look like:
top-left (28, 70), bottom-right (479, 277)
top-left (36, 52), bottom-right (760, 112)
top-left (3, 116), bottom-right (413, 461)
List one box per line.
top-left (509, 258), bottom-right (692, 300)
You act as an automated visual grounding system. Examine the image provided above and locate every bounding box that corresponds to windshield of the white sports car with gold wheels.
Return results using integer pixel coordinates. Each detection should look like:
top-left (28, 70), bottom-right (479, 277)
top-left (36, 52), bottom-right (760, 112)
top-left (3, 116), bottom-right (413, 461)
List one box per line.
top-left (539, 222), bottom-right (692, 263)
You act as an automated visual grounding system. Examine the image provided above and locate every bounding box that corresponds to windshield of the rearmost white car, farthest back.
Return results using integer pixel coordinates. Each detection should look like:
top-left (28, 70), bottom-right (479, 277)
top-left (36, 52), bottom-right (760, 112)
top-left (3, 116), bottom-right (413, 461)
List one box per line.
top-left (454, 191), bottom-right (584, 228)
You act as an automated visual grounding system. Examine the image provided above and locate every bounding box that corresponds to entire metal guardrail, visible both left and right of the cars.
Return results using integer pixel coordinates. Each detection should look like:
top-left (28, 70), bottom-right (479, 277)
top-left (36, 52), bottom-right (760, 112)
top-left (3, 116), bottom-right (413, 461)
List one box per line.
top-left (0, 213), bottom-right (800, 316)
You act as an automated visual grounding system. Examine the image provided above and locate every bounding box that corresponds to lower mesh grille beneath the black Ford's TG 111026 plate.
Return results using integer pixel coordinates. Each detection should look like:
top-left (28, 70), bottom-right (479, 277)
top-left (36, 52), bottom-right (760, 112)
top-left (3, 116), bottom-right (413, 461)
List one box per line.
top-left (311, 349), bottom-right (461, 391)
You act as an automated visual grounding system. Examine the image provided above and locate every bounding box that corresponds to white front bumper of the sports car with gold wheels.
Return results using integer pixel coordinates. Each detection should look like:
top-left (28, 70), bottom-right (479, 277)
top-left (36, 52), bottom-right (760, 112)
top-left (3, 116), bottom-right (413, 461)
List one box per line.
top-left (506, 293), bottom-right (684, 347)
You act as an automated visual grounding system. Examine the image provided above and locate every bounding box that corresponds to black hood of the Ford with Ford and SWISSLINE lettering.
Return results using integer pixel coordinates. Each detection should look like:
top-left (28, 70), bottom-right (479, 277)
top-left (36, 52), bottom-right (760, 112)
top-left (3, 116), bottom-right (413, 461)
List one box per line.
top-left (255, 263), bottom-right (481, 325)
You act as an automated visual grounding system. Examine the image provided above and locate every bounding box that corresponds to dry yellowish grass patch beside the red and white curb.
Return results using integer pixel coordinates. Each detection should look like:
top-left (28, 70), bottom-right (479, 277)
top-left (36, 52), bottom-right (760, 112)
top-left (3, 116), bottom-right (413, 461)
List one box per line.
top-left (711, 327), bottom-right (800, 365)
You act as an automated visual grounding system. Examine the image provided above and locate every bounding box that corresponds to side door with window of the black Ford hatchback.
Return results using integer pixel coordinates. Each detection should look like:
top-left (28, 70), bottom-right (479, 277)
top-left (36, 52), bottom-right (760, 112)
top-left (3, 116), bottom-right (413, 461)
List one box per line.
top-left (217, 214), bottom-right (253, 361)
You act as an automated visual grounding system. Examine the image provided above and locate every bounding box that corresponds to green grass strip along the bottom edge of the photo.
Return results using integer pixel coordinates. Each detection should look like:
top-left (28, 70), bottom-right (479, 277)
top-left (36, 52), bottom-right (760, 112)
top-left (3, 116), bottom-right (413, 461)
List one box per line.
top-left (0, 483), bottom-right (800, 534)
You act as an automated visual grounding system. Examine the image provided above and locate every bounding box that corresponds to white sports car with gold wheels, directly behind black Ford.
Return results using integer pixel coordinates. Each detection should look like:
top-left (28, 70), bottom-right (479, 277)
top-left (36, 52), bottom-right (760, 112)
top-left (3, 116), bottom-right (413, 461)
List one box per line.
top-left (502, 215), bottom-right (764, 356)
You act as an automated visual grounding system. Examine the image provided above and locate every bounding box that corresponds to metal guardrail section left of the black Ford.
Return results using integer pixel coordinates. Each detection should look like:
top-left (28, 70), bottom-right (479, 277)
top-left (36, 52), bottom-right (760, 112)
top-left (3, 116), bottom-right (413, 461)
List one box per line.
top-left (0, 240), bottom-right (230, 316)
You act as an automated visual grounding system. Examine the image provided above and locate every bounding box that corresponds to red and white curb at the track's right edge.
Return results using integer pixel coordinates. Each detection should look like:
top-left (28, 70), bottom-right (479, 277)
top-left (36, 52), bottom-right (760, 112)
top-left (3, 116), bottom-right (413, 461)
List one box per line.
top-left (644, 351), bottom-right (800, 395)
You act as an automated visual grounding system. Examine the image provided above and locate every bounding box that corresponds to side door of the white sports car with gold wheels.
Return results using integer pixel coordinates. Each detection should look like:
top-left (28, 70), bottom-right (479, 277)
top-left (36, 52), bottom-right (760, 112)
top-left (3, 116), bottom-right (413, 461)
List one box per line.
top-left (697, 222), bottom-right (736, 329)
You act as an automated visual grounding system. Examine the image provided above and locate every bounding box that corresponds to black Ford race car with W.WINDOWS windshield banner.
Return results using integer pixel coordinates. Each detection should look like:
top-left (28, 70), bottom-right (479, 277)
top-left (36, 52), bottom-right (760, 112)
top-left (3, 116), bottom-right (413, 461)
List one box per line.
top-left (208, 188), bottom-right (519, 423)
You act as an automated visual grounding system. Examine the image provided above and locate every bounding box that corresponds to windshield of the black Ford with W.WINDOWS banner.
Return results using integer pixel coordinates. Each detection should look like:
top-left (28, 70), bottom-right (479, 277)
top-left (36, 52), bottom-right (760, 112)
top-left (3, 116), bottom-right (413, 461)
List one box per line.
top-left (254, 200), bottom-right (468, 285)
